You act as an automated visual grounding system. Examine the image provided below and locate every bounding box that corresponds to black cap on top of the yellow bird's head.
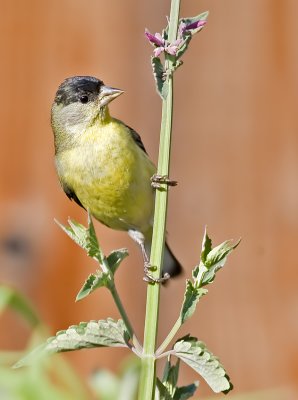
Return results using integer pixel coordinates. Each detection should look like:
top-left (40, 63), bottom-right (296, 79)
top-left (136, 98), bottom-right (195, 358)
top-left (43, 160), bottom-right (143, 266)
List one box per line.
top-left (55, 76), bottom-right (104, 106)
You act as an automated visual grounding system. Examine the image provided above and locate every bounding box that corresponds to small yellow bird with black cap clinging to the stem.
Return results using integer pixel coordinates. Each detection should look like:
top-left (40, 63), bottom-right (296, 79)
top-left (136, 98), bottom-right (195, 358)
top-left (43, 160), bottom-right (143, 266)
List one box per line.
top-left (51, 76), bottom-right (182, 282)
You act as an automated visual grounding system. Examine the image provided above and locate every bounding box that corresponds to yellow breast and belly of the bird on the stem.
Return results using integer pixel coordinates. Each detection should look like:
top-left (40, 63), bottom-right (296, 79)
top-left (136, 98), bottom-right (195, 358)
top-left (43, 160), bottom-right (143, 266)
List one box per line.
top-left (58, 123), bottom-right (155, 232)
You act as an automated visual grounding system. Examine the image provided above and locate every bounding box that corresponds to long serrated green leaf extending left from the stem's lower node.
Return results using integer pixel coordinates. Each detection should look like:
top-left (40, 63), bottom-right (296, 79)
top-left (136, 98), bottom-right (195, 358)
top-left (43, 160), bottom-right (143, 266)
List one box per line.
top-left (14, 318), bottom-right (129, 368)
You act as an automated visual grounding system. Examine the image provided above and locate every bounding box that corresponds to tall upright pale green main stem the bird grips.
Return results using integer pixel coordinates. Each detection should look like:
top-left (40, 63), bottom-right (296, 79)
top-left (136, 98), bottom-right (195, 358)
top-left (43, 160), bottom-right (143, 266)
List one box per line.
top-left (138, 0), bottom-right (180, 400)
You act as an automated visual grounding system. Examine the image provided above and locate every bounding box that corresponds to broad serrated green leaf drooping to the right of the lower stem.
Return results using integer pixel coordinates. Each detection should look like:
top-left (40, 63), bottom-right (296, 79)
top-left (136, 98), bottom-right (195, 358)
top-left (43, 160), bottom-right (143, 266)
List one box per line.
top-left (174, 336), bottom-right (232, 393)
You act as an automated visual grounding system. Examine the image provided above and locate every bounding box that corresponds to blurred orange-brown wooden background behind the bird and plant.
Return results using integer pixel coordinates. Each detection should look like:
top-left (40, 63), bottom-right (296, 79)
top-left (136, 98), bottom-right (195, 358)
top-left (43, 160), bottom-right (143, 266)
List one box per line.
top-left (0, 0), bottom-right (298, 399)
